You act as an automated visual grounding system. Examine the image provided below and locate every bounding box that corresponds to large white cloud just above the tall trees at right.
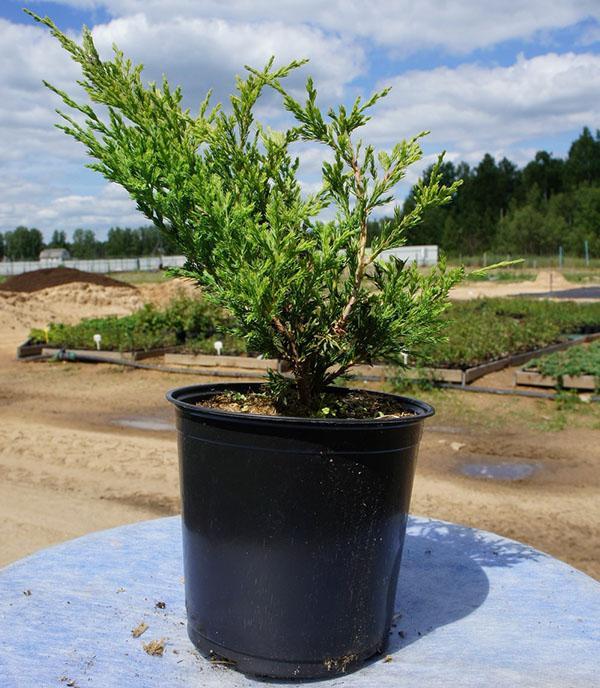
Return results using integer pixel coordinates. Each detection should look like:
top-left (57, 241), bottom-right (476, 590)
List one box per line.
top-left (368, 53), bottom-right (600, 156)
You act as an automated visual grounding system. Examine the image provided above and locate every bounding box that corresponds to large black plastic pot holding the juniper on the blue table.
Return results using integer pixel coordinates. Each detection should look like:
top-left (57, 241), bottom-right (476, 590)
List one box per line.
top-left (167, 384), bottom-right (434, 678)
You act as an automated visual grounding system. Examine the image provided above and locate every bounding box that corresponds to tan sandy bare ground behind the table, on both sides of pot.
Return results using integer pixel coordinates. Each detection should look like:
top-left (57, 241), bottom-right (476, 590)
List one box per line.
top-left (0, 274), bottom-right (600, 579)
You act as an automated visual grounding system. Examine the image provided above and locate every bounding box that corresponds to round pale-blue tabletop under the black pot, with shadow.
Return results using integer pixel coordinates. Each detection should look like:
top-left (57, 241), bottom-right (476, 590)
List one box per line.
top-left (0, 518), bottom-right (600, 688)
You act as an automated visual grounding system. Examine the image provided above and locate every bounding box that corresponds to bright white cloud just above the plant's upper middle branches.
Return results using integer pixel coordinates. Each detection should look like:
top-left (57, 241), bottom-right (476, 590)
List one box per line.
top-left (88, 13), bottom-right (364, 105)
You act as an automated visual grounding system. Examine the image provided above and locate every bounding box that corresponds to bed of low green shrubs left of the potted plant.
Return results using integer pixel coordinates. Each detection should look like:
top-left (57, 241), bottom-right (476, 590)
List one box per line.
top-left (29, 297), bottom-right (228, 351)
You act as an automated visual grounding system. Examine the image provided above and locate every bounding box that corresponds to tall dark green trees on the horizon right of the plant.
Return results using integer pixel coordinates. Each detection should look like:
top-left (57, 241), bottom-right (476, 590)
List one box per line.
top-left (370, 127), bottom-right (600, 256)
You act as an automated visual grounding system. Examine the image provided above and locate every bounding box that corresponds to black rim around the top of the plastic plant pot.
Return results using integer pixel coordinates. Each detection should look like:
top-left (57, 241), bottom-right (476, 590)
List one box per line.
top-left (165, 382), bottom-right (435, 429)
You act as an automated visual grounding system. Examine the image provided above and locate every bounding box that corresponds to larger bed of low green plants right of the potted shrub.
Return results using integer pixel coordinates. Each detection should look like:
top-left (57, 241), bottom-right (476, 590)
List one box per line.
top-left (414, 299), bottom-right (600, 368)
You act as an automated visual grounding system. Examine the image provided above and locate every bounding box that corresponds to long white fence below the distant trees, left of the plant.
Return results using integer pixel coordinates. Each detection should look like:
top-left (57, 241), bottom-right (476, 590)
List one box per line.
top-left (0, 256), bottom-right (185, 275)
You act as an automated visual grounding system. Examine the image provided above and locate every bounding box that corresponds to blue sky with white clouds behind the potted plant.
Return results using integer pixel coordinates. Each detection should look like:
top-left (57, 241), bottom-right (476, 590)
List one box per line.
top-left (0, 0), bottom-right (600, 238)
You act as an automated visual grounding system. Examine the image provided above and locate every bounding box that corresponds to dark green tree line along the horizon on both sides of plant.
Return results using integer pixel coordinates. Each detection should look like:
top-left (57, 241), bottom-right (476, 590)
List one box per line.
top-left (0, 127), bottom-right (600, 260)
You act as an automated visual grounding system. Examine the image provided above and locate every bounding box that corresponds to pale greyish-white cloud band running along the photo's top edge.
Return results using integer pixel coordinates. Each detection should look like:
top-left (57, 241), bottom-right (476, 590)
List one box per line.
top-left (39, 0), bottom-right (600, 54)
